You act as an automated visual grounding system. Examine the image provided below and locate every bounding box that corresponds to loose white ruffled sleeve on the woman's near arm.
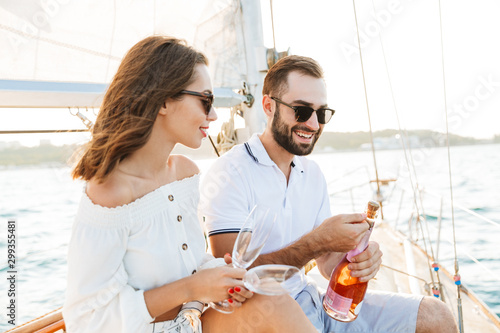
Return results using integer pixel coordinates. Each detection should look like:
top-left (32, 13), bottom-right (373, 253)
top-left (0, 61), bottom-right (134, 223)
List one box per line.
top-left (63, 198), bottom-right (154, 333)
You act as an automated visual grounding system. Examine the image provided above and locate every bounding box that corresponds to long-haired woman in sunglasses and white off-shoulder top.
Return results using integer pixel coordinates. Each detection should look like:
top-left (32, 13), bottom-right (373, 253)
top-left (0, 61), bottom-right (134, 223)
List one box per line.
top-left (63, 36), bottom-right (314, 332)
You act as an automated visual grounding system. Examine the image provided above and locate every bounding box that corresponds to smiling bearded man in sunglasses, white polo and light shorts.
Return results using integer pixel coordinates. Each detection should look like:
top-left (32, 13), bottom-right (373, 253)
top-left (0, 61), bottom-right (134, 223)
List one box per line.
top-left (199, 56), bottom-right (457, 332)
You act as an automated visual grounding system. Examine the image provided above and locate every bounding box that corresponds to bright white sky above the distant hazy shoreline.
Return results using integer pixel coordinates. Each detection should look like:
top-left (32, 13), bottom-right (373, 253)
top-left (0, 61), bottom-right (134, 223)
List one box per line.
top-left (0, 0), bottom-right (500, 145)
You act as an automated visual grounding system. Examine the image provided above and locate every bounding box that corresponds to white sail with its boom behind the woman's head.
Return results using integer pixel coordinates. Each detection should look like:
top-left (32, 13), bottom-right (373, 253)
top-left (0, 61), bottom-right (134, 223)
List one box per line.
top-left (0, 0), bottom-right (262, 115)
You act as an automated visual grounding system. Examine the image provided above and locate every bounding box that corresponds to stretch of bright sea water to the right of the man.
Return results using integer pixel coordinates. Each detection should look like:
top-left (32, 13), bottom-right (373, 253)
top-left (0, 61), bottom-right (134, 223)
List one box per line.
top-left (311, 144), bottom-right (500, 315)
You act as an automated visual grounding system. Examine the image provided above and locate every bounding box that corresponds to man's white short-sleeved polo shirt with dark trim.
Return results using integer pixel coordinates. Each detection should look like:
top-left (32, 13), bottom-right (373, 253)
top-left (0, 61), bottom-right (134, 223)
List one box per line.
top-left (198, 134), bottom-right (331, 253)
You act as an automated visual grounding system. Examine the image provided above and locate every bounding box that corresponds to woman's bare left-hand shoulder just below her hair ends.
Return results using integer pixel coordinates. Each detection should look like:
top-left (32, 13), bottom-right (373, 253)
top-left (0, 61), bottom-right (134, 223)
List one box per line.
top-left (86, 174), bottom-right (135, 208)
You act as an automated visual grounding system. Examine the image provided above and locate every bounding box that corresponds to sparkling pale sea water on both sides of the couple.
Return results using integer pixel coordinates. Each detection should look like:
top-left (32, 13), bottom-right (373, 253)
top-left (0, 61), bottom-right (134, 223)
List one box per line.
top-left (0, 145), bottom-right (500, 330)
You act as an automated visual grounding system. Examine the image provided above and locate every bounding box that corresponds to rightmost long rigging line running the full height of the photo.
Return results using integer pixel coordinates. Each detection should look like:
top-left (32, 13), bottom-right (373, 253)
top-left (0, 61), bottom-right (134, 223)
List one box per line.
top-left (438, 0), bottom-right (464, 332)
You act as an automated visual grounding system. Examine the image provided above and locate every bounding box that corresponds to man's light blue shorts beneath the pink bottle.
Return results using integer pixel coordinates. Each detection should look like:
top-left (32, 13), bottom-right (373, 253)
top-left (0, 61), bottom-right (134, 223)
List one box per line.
top-left (295, 282), bottom-right (423, 333)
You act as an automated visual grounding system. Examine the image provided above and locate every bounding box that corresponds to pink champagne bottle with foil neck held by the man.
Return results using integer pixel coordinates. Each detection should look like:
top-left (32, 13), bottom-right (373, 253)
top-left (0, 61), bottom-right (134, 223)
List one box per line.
top-left (323, 201), bottom-right (380, 322)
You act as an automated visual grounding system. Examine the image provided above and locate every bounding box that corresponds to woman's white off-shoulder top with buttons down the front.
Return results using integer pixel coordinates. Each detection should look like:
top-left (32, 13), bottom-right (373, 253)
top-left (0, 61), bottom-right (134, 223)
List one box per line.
top-left (63, 175), bottom-right (206, 333)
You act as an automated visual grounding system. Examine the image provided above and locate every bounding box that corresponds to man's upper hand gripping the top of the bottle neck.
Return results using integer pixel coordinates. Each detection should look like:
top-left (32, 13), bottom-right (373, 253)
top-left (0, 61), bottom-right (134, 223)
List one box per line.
top-left (313, 214), bottom-right (369, 253)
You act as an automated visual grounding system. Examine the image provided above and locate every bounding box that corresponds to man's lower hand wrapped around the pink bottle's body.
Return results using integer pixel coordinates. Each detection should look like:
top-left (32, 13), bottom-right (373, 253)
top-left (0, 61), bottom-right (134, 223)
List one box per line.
top-left (348, 242), bottom-right (383, 282)
